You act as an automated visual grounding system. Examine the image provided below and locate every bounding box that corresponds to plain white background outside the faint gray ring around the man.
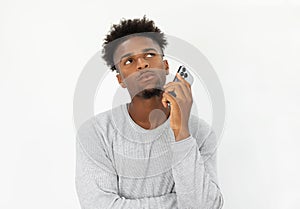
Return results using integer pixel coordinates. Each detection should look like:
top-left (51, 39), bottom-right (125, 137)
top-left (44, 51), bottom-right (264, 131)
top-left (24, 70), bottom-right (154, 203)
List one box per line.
top-left (0, 0), bottom-right (300, 209)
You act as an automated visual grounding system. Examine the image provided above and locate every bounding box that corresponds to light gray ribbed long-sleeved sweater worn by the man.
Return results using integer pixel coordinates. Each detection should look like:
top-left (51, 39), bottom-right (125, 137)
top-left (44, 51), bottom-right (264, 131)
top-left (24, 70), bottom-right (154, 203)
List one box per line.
top-left (76, 104), bottom-right (223, 209)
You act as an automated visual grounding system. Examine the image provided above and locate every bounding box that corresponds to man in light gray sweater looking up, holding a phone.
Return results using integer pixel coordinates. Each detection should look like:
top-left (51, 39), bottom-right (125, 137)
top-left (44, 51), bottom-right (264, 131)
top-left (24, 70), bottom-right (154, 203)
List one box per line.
top-left (76, 17), bottom-right (223, 209)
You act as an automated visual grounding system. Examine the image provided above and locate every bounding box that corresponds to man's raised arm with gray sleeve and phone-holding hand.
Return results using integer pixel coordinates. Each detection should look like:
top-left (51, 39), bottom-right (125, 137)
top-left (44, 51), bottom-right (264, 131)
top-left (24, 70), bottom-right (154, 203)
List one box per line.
top-left (162, 73), bottom-right (223, 209)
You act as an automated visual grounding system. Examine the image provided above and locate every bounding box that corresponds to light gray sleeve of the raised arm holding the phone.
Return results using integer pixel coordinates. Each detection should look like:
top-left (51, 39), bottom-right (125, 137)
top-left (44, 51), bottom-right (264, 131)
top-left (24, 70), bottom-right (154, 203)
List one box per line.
top-left (171, 125), bottom-right (223, 209)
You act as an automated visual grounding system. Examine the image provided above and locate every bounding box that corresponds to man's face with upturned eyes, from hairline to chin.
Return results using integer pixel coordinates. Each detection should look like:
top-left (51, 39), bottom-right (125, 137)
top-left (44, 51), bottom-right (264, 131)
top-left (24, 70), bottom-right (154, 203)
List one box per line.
top-left (114, 36), bottom-right (169, 97)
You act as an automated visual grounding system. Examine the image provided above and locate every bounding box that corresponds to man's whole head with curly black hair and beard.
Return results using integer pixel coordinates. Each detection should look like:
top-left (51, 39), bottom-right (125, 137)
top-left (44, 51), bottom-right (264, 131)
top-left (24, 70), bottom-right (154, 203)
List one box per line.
top-left (103, 16), bottom-right (169, 98)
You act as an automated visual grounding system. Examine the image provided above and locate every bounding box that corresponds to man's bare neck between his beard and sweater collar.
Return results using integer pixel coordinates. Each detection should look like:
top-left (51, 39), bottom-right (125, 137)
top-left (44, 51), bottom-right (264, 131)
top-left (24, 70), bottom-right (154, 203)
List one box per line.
top-left (128, 95), bottom-right (170, 129)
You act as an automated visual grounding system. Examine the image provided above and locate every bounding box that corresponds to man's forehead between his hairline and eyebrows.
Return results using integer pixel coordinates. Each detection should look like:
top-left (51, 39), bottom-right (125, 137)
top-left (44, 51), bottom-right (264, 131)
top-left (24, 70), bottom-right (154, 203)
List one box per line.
top-left (114, 36), bottom-right (161, 61)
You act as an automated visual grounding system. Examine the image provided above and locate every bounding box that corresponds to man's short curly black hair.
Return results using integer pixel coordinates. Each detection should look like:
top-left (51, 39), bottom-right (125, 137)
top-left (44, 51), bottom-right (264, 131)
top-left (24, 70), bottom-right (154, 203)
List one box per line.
top-left (102, 15), bottom-right (167, 72)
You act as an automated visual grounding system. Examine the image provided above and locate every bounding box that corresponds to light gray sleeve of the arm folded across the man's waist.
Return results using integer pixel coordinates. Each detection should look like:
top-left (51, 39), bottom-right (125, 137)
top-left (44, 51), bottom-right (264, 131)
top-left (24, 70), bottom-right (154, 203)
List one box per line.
top-left (76, 119), bottom-right (177, 209)
